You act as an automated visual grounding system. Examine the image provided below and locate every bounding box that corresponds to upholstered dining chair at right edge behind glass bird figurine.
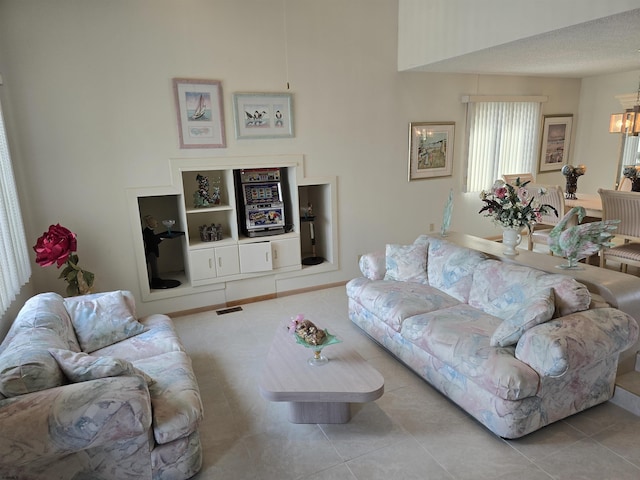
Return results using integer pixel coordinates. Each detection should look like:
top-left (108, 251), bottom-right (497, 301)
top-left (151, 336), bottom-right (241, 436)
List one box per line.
top-left (598, 188), bottom-right (640, 273)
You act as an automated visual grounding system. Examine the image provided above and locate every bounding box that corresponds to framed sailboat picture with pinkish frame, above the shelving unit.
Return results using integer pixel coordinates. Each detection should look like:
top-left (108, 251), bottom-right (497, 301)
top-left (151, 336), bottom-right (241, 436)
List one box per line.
top-left (173, 78), bottom-right (227, 148)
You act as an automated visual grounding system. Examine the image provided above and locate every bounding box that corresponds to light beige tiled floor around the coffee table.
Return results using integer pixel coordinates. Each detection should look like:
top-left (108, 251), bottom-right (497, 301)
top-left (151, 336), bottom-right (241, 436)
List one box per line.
top-left (175, 287), bottom-right (640, 480)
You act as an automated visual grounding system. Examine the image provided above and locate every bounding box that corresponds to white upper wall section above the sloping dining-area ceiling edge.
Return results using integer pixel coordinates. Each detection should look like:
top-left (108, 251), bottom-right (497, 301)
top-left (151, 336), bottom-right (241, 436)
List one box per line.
top-left (398, 0), bottom-right (640, 71)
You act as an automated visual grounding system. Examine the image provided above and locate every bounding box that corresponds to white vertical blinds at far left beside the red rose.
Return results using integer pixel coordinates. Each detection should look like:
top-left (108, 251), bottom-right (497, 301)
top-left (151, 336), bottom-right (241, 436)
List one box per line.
top-left (0, 96), bottom-right (31, 315)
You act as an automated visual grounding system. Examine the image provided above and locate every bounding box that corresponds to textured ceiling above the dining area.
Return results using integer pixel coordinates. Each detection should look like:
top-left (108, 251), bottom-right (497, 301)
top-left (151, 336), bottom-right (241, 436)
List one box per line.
top-left (413, 9), bottom-right (640, 78)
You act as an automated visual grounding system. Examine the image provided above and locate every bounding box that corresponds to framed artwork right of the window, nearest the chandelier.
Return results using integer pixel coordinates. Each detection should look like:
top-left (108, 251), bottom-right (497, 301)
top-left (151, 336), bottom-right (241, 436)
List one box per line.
top-left (538, 115), bottom-right (573, 173)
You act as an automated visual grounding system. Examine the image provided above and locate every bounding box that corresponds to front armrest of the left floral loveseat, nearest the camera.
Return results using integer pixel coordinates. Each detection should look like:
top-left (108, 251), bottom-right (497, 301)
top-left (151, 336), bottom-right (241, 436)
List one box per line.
top-left (0, 375), bottom-right (152, 471)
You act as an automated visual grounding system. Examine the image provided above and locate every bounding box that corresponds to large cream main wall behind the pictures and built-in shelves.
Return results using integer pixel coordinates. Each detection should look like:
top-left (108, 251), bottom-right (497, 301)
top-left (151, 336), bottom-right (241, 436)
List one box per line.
top-left (0, 0), bottom-right (617, 322)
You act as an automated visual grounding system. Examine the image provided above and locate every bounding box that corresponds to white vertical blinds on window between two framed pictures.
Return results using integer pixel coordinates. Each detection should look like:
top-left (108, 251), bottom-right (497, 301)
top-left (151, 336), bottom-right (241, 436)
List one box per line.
top-left (467, 102), bottom-right (540, 192)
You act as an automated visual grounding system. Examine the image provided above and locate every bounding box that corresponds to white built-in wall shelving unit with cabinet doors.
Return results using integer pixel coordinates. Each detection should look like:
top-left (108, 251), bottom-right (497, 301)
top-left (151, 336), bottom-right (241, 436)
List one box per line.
top-left (128, 155), bottom-right (338, 301)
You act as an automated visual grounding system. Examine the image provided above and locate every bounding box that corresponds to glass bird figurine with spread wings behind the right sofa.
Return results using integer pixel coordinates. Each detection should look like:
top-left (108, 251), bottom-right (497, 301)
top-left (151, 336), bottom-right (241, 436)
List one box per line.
top-left (549, 207), bottom-right (620, 268)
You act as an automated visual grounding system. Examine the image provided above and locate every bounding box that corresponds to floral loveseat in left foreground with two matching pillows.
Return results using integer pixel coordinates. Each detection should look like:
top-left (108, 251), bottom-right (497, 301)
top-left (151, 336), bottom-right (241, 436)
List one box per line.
top-left (0, 291), bottom-right (203, 480)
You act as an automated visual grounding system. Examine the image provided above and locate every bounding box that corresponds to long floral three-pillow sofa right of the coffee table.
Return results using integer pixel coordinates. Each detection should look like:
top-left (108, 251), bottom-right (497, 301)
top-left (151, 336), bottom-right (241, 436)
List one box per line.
top-left (346, 235), bottom-right (638, 438)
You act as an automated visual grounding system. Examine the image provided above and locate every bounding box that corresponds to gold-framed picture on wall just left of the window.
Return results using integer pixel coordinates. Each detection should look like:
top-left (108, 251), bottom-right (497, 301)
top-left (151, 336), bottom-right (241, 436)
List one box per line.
top-left (409, 122), bottom-right (456, 181)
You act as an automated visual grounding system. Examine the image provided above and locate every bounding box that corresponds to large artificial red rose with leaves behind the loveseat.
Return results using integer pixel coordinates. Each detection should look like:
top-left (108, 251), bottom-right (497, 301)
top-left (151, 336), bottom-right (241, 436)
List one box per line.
top-left (33, 223), bottom-right (95, 296)
